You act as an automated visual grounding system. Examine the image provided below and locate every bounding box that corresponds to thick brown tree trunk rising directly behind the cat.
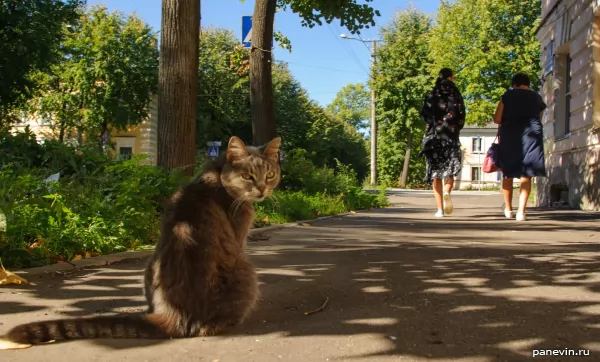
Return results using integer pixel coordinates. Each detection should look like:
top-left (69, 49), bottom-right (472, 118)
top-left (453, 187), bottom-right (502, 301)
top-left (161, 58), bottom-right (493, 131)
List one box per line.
top-left (158, 0), bottom-right (200, 176)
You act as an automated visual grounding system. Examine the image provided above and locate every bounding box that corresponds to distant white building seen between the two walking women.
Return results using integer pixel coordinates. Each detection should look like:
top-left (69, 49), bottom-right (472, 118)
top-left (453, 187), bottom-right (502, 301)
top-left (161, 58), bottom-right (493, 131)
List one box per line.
top-left (454, 122), bottom-right (508, 189)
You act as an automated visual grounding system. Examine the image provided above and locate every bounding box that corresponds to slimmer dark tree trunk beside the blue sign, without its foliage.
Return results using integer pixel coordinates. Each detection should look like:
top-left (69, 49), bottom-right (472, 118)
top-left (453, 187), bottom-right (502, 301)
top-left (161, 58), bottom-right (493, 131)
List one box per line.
top-left (250, 0), bottom-right (277, 145)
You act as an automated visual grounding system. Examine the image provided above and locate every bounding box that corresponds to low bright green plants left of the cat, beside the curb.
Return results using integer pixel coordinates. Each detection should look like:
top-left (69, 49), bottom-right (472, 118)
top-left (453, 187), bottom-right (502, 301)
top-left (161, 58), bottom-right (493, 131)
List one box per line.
top-left (0, 158), bottom-right (181, 267)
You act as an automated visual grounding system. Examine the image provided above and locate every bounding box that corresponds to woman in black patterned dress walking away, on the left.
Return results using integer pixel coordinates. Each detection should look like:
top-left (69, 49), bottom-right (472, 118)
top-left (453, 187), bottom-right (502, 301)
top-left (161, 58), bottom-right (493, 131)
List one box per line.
top-left (421, 68), bottom-right (465, 217)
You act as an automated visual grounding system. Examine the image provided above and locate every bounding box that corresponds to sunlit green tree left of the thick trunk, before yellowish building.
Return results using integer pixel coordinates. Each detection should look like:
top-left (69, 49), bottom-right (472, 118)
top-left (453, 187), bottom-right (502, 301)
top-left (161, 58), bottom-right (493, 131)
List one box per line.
top-left (30, 6), bottom-right (158, 143)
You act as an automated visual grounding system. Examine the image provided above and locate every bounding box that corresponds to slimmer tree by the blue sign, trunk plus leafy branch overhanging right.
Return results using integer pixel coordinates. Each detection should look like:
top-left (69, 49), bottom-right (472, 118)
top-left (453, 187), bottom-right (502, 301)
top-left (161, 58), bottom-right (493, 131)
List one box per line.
top-left (250, 0), bottom-right (380, 144)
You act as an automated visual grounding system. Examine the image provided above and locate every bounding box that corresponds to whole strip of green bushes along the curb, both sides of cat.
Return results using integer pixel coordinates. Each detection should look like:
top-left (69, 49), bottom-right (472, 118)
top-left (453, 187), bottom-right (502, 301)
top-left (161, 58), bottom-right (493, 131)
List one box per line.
top-left (0, 130), bottom-right (387, 267)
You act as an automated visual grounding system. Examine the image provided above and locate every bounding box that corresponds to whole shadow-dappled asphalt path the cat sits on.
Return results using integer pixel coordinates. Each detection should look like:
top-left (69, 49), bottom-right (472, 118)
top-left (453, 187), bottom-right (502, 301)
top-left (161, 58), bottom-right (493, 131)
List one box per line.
top-left (0, 194), bottom-right (600, 362)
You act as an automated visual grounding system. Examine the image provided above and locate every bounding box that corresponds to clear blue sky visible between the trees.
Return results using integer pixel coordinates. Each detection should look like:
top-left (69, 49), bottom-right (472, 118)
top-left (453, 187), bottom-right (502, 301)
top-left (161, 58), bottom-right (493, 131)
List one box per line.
top-left (88, 0), bottom-right (440, 106)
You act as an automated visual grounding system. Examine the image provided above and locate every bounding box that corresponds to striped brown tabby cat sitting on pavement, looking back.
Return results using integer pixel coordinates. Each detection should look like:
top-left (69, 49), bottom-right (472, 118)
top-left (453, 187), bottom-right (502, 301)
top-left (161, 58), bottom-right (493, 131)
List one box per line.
top-left (0, 136), bottom-right (281, 349)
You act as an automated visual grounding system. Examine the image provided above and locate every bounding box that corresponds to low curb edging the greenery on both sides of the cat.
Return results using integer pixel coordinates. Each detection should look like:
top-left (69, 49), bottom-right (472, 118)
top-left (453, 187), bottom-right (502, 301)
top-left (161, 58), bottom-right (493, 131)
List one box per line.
top-left (12, 210), bottom-right (368, 279)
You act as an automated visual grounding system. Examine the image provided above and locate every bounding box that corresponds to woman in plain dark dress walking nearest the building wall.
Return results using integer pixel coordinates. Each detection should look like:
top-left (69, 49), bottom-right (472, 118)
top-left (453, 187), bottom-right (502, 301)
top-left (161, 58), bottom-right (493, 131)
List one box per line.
top-left (494, 73), bottom-right (546, 221)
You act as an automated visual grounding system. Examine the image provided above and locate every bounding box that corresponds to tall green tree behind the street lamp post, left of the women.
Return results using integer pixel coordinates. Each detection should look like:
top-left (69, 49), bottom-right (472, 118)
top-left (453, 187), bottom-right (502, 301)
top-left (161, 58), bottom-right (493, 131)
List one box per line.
top-left (373, 8), bottom-right (433, 187)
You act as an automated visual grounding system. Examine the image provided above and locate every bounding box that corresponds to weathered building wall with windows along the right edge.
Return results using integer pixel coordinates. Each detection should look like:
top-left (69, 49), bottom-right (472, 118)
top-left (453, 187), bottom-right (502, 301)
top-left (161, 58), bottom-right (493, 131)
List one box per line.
top-left (536, 0), bottom-right (600, 210)
